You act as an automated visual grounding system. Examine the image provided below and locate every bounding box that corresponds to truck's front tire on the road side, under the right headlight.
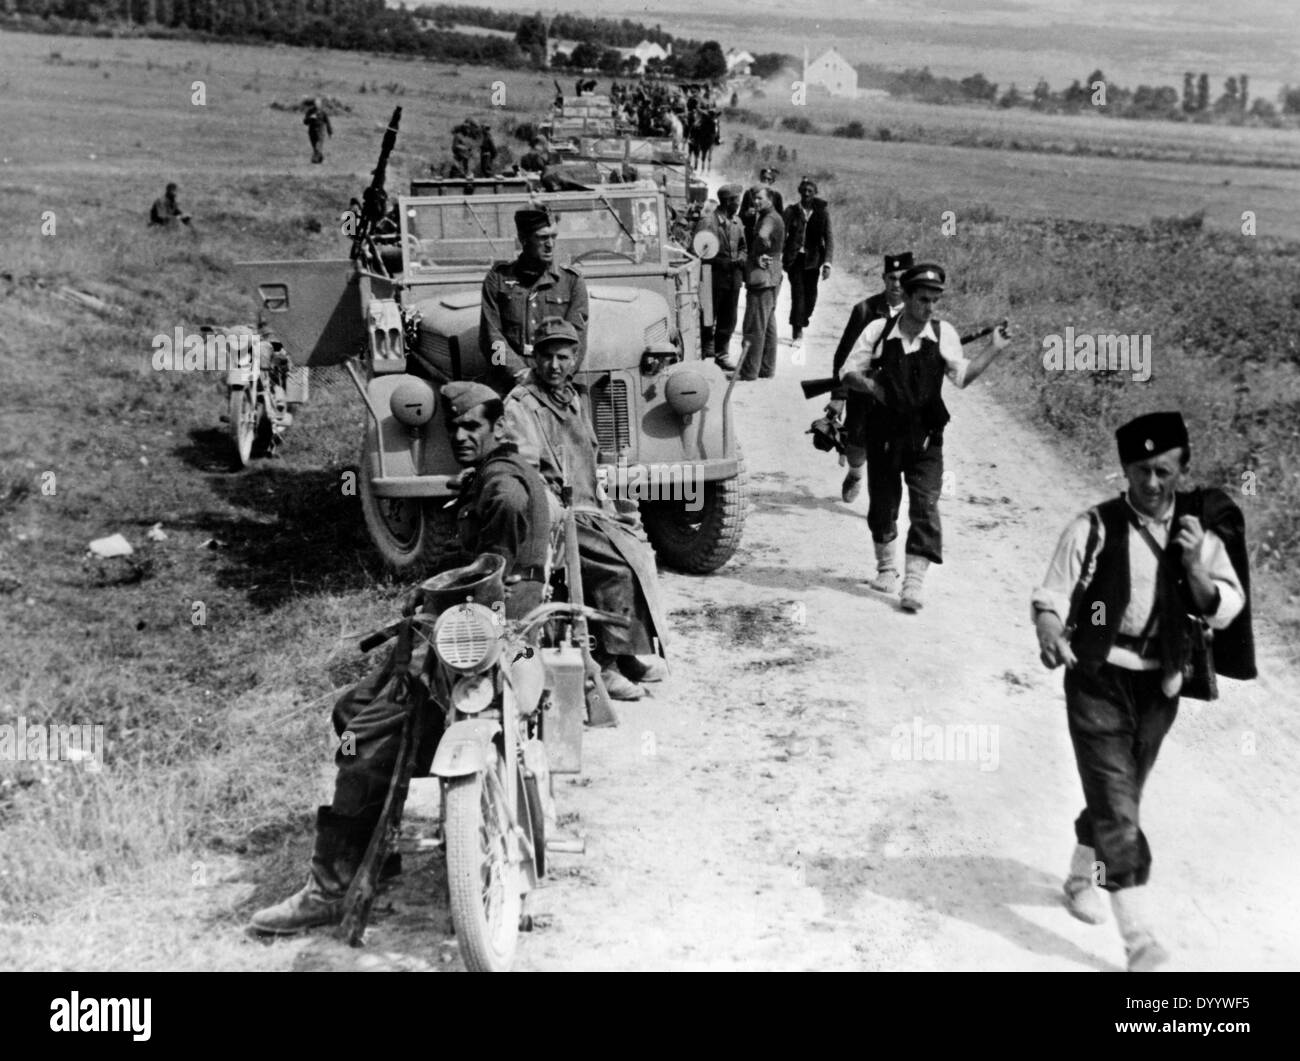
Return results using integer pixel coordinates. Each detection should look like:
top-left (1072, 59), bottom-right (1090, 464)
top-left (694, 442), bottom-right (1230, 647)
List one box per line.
top-left (641, 446), bottom-right (749, 575)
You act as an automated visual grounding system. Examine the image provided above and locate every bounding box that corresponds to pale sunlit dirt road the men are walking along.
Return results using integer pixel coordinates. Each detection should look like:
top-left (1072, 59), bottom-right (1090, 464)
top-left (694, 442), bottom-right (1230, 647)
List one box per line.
top-left (279, 254), bottom-right (1300, 971)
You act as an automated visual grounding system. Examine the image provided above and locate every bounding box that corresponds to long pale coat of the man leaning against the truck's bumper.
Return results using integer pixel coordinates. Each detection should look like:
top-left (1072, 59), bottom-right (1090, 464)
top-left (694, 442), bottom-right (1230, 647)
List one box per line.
top-left (506, 380), bottom-right (668, 655)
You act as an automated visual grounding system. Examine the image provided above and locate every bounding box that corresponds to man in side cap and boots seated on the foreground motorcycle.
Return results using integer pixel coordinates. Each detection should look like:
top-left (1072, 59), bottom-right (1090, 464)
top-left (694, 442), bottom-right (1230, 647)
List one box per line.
top-left (250, 381), bottom-right (551, 935)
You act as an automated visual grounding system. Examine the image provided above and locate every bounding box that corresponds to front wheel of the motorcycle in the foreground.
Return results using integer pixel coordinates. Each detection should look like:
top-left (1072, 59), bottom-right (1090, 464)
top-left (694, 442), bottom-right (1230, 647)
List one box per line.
top-left (445, 753), bottom-right (524, 973)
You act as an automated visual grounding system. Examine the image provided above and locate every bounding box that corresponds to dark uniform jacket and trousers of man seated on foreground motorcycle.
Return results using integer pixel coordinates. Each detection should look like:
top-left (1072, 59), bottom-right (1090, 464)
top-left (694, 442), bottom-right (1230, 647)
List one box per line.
top-left (333, 445), bottom-right (551, 823)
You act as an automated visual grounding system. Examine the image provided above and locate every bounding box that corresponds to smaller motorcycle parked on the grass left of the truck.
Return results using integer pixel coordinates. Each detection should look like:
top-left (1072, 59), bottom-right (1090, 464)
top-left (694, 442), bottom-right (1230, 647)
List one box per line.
top-left (202, 325), bottom-right (297, 468)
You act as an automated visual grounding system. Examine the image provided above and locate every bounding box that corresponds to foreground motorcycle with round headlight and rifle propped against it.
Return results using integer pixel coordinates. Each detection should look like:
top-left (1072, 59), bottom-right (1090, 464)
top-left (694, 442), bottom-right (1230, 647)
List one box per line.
top-left (339, 553), bottom-right (628, 971)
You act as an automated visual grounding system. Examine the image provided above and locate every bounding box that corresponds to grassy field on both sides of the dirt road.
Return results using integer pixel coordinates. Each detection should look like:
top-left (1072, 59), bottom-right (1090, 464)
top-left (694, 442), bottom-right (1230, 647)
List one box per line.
top-left (0, 35), bottom-right (1300, 965)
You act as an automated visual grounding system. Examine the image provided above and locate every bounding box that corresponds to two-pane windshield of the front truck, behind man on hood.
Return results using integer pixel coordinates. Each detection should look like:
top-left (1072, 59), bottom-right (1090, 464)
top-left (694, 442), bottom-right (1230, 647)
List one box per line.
top-left (403, 195), bottom-right (663, 273)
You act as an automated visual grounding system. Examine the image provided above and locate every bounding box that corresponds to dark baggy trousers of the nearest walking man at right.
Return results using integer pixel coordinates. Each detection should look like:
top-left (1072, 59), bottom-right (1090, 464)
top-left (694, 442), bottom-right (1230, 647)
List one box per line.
top-left (1065, 661), bottom-right (1178, 891)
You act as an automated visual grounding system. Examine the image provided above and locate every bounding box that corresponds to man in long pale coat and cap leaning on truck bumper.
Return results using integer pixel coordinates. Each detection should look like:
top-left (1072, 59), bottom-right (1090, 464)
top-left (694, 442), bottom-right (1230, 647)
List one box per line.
top-left (504, 320), bottom-right (667, 700)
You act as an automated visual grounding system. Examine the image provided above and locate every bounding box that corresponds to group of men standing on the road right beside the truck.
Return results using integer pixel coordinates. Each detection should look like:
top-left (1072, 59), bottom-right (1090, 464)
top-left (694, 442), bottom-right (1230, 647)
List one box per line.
top-left (701, 168), bottom-right (835, 380)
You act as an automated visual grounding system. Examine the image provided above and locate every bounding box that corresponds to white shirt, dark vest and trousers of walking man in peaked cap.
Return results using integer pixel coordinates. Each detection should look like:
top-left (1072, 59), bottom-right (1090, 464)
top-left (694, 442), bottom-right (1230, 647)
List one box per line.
top-left (842, 317), bottom-right (970, 563)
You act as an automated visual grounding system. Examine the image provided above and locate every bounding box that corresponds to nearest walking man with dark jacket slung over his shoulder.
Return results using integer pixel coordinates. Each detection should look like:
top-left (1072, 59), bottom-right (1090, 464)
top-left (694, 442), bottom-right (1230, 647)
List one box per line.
top-left (1032, 412), bottom-right (1256, 971)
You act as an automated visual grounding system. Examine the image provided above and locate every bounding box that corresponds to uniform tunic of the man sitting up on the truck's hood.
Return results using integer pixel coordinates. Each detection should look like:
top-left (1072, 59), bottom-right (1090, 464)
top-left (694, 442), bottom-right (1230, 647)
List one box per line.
top-left (478, 259), bottom-right (588, 397)
